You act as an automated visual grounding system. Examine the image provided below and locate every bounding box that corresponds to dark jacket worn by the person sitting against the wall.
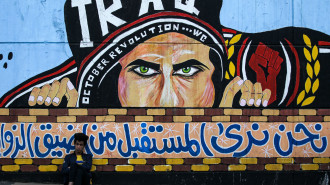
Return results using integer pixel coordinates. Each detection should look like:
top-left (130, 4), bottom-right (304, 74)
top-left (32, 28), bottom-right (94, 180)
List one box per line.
top-left (62, 152), bottom-right (92, 184)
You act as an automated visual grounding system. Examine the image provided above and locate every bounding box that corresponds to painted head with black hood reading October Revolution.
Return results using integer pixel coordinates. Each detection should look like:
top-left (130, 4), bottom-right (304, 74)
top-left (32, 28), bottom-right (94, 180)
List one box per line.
top-left (66, 0), bottom-right (227, 108)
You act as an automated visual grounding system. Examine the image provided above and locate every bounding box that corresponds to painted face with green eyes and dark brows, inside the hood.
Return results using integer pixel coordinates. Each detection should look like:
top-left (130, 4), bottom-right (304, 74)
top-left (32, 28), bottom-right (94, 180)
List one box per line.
top-left (118, 33), bottom-right (215, 107)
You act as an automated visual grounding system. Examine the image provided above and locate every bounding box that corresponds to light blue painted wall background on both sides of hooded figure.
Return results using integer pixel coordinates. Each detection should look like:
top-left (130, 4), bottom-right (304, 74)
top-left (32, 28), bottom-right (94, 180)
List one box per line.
top-left (0, 0), bottom-right (330, 96)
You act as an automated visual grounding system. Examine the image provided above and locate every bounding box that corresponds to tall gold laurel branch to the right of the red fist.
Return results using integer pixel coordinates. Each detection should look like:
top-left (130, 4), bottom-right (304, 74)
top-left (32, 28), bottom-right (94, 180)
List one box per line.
top-left (297, 34), bottom-right (321, 107)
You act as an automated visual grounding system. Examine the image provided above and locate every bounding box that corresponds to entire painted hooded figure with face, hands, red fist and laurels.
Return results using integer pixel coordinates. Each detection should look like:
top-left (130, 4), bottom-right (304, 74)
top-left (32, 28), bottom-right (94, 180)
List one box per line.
top-left (0, 0), bottom-right (330, 108)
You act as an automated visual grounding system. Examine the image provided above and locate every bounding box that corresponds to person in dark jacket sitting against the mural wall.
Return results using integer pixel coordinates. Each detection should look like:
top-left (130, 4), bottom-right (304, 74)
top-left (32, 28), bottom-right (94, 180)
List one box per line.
top-left (62, 133), bottom-right (92, 185)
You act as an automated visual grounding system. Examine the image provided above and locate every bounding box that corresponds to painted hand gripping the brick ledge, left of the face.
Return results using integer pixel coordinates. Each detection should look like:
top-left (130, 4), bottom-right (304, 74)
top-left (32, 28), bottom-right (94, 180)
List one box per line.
top-left (28, 78), bottom-right (78, 107)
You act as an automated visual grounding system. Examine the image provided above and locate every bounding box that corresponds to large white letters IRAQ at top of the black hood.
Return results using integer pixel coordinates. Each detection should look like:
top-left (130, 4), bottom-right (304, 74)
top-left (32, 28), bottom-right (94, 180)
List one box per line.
top-left (71, 0), bottom-right (199, 48)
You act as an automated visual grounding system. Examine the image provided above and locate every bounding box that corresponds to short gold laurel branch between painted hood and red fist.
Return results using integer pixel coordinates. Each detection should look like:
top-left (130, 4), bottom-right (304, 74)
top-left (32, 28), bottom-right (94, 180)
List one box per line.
top-left (225, 34), bottom-right (242, 80)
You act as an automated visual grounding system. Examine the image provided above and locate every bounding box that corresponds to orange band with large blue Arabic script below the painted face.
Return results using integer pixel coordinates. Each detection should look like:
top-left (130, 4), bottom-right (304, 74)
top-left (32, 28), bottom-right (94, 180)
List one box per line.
top-left (0, 122), bottom-right (330, 158)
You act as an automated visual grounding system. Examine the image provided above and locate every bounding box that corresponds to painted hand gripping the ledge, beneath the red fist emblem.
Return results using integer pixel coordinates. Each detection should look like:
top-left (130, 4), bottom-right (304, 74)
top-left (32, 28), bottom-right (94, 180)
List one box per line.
top-left (220, 77), bottom-right (271, 107)
